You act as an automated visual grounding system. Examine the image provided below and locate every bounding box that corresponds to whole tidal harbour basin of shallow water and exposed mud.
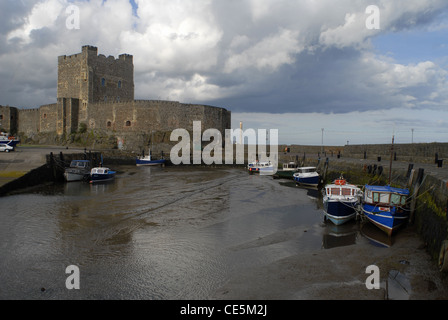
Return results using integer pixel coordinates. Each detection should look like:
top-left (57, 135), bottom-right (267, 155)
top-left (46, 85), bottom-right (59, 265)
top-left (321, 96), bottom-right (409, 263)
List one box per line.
top-left (0, 147), bottom-right (447, 300)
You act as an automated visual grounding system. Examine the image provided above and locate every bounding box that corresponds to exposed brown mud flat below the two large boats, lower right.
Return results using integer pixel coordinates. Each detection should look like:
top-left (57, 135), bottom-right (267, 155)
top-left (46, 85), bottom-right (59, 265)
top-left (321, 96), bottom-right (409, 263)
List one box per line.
top-left (212, 228), bottom-right (448, 300)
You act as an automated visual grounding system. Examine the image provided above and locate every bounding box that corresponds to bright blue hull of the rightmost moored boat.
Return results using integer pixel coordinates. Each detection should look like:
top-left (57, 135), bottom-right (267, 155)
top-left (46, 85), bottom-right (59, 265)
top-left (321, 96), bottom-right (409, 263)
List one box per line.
top-left (362, 204), bottom-right (409, 236)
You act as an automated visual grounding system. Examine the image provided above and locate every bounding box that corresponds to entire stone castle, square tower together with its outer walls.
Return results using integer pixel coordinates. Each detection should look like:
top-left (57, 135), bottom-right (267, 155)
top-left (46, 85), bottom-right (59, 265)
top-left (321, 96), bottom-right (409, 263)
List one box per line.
top-left (0, 46), bottom-right (231, 151)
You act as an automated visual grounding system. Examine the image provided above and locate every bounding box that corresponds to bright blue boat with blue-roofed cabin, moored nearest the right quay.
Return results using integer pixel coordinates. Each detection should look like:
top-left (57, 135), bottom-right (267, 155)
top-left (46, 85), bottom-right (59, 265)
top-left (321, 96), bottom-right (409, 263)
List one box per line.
top-left (362, 185), bottom-right (409, 236)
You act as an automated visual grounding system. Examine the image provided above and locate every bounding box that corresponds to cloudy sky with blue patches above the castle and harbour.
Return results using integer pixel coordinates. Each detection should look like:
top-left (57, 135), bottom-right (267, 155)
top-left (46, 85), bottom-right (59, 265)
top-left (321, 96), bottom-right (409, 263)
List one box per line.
top-left (0, 0), bottom-right (448, 145)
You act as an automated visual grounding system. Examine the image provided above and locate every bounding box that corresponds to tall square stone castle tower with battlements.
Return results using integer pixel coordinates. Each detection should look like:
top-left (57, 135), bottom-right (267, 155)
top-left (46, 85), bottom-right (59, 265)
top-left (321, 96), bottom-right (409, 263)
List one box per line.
top-left (57, 46), bottom-right (134, 135)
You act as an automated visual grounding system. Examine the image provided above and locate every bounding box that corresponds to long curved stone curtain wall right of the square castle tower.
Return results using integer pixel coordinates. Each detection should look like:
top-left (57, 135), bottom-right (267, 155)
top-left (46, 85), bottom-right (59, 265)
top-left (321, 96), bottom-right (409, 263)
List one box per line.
top-left (86, 100), bottom-right (231, 152)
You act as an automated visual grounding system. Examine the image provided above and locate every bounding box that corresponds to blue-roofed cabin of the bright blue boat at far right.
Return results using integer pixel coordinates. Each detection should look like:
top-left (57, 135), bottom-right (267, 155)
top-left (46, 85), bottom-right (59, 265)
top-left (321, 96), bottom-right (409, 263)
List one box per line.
top-left (364, 186), bottom-right (409, 207)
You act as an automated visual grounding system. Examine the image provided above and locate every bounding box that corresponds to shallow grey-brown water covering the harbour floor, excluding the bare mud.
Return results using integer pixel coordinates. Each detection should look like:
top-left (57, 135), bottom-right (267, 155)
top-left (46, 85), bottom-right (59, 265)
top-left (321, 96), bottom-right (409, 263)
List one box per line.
top-left (0, 166), bottom-right (392, 299)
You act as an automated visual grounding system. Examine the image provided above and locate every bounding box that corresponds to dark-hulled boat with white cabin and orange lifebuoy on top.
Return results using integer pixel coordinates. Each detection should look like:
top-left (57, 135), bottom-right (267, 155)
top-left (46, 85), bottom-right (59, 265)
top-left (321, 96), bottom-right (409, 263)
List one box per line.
top-left (322, 176), bottom-right (362, 225)
